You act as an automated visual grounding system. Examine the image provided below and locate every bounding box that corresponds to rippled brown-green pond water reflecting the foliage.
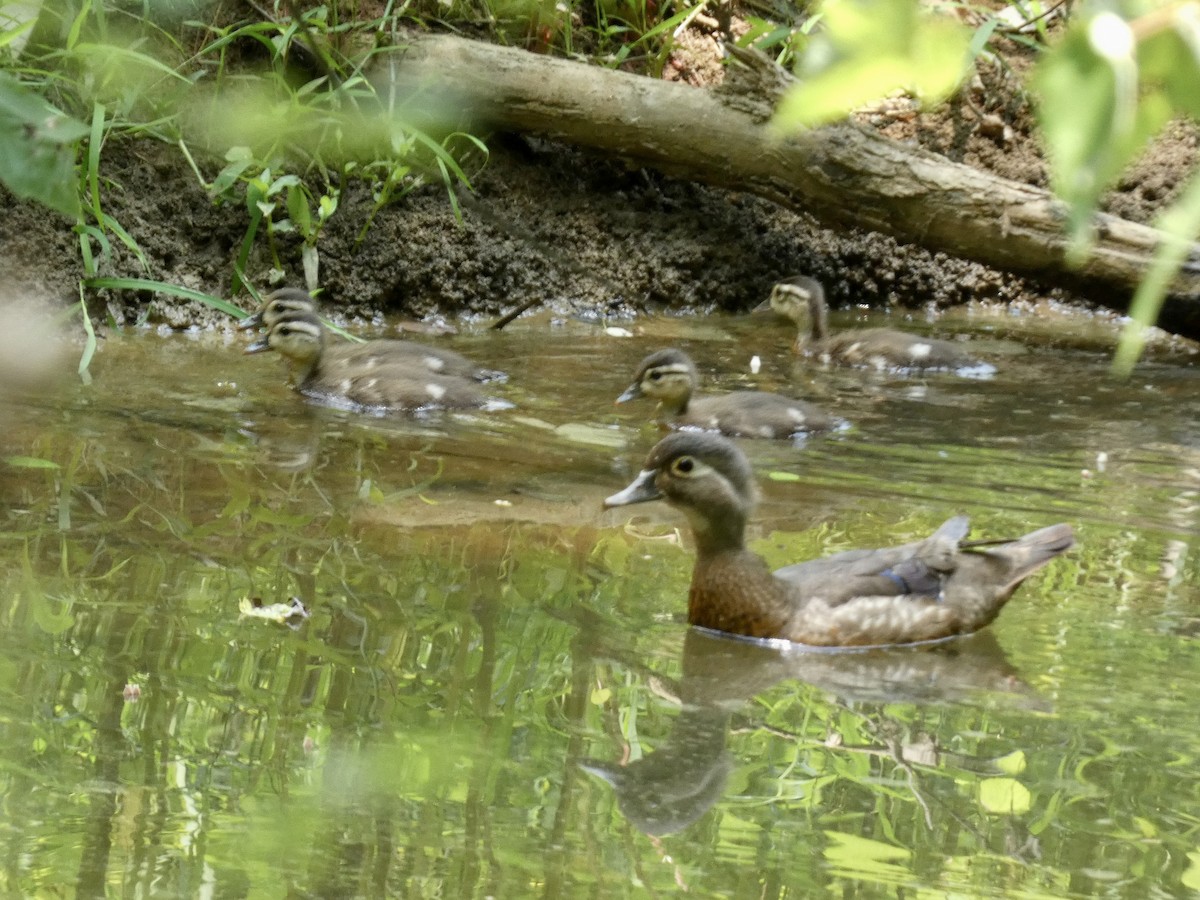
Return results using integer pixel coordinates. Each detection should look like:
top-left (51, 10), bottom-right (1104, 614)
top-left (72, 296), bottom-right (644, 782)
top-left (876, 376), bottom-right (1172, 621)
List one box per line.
top-left (0, 301), bottom-right (1200, 898)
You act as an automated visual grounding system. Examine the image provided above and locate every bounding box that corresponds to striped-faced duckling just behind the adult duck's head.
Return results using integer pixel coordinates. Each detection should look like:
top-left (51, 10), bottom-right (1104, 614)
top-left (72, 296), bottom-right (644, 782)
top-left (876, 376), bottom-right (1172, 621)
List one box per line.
top-left (617, 349), bottom-right (836, 438)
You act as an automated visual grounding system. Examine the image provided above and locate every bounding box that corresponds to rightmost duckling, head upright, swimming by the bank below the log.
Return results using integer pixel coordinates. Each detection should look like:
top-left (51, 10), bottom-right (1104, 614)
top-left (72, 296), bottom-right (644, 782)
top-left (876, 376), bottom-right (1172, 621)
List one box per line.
top-left (756, 275), bottom-right (995, 374)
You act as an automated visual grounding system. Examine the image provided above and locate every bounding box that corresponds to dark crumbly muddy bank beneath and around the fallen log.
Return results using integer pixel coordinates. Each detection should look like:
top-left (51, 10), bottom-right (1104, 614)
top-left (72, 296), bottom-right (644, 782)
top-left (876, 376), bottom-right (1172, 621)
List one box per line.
top-left (0, 65), bottom-right (1198, 338)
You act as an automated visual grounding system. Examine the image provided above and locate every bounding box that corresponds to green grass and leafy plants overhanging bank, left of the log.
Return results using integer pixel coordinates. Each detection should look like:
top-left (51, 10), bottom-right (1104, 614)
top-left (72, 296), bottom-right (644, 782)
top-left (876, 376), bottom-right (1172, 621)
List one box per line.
top-left (0, 1), bottom-right (486, 321)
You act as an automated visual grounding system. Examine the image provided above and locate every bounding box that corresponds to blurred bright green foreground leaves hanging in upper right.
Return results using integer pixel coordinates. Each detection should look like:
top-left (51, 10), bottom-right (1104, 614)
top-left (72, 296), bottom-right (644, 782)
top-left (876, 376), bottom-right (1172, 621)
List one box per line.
top-left (748, 0), bottom-right (1200, 367)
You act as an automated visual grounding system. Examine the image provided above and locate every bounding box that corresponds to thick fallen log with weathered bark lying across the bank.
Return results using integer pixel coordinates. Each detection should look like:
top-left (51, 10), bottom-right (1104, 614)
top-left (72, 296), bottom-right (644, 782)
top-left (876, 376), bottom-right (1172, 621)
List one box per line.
top-left (400, 36), bottom-right (1200, 337)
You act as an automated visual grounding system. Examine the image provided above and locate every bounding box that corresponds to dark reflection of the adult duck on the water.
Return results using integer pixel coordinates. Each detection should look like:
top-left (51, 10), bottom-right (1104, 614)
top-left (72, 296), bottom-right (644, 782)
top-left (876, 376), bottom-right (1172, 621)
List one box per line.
top-left (581, 628), bottom-right (1039, 836)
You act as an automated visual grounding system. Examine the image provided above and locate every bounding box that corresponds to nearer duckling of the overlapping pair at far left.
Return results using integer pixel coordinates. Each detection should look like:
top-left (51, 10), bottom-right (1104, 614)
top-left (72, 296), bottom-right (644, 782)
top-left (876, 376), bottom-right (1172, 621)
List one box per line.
top-left (246, 311), bottom-right (490, 410)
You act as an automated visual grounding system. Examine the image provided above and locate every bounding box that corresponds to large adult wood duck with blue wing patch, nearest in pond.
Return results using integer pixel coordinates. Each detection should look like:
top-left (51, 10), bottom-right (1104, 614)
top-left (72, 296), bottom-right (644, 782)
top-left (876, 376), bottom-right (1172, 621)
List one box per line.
top-left (605, 433), bottom-right (1074, 647)
